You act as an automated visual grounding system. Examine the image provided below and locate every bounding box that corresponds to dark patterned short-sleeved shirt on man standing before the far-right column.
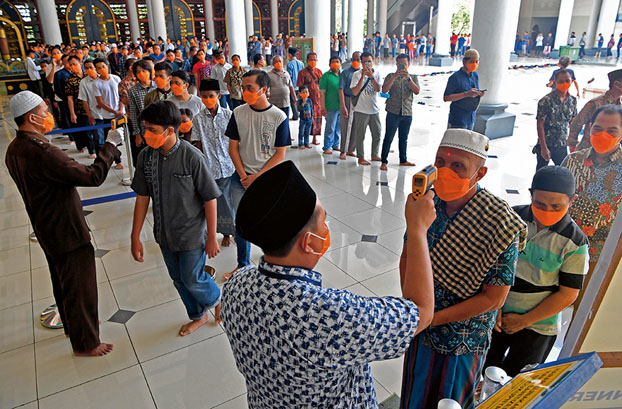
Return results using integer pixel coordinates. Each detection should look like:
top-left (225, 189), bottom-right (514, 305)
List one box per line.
top-left (536, 90), bottom-right (577, 148)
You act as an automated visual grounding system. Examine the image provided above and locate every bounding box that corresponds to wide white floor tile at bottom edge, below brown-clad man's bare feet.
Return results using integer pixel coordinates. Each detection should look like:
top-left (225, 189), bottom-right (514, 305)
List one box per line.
top-left (39, 365), bottom-right (155, 409)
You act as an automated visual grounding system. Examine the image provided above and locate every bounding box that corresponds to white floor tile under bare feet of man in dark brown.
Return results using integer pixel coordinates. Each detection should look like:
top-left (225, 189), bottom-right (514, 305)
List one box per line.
top-left (35, 322), bottom-right (138, 398)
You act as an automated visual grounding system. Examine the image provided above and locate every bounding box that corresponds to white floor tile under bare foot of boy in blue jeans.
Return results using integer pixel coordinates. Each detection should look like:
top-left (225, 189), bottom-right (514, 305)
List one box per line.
top-left (126, 300), bottom-right (223, 362)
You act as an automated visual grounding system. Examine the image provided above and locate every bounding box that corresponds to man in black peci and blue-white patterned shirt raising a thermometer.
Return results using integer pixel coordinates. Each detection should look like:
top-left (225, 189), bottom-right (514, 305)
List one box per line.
top-left (221, 161), bottom-right (435, 408)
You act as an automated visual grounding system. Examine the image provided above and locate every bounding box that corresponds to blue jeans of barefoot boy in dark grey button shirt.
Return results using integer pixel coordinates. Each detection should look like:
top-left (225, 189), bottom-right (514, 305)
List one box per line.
top-left (160, 246), bottom-right (220, 320)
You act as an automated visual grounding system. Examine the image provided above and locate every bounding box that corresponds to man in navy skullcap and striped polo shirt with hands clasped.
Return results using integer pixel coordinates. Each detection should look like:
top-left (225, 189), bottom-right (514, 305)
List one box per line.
top-left (484, 166), bottom-right (589, 376)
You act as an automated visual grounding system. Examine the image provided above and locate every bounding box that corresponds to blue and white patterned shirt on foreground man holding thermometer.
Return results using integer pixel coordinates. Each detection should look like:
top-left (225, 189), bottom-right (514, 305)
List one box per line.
top-left (221, 258), bottom-right (419, 409)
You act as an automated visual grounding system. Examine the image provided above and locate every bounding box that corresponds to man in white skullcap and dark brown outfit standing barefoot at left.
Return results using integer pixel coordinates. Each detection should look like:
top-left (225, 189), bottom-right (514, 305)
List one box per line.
top-left (5, 91), bottom-right (121, 356)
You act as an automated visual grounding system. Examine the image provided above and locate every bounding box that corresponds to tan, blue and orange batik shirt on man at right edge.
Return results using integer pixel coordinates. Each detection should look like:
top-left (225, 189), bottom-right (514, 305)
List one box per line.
top-left (562, 147), bottom-right (622, 263)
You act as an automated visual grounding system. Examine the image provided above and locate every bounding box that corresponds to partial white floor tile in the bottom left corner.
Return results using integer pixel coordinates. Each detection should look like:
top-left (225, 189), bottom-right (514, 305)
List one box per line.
top-left (0, 344), bottom-right (37, 408)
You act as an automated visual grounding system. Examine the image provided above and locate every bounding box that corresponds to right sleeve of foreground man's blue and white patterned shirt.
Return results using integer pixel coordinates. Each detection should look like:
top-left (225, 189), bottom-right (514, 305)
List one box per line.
top-left (293, 290), bottom-right (419, 370)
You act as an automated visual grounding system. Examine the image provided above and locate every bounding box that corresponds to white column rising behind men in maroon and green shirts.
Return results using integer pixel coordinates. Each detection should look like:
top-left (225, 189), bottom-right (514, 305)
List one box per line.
top-left (305, 0), bottom-right (330, 72)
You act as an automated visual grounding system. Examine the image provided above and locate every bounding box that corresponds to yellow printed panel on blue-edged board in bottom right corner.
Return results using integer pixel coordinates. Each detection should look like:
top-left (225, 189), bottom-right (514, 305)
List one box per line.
top-left (477, 362), bottom-right (578, 409)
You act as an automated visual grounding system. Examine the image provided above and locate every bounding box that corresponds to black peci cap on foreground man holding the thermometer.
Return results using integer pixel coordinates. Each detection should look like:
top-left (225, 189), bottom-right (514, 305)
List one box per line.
top-left (235, 161), bottom-right (317, 251)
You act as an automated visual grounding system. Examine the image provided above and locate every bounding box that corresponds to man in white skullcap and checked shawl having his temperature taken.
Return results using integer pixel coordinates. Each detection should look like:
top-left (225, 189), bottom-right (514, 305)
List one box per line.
top-left (400, 129), bottom-right (526, 409)
